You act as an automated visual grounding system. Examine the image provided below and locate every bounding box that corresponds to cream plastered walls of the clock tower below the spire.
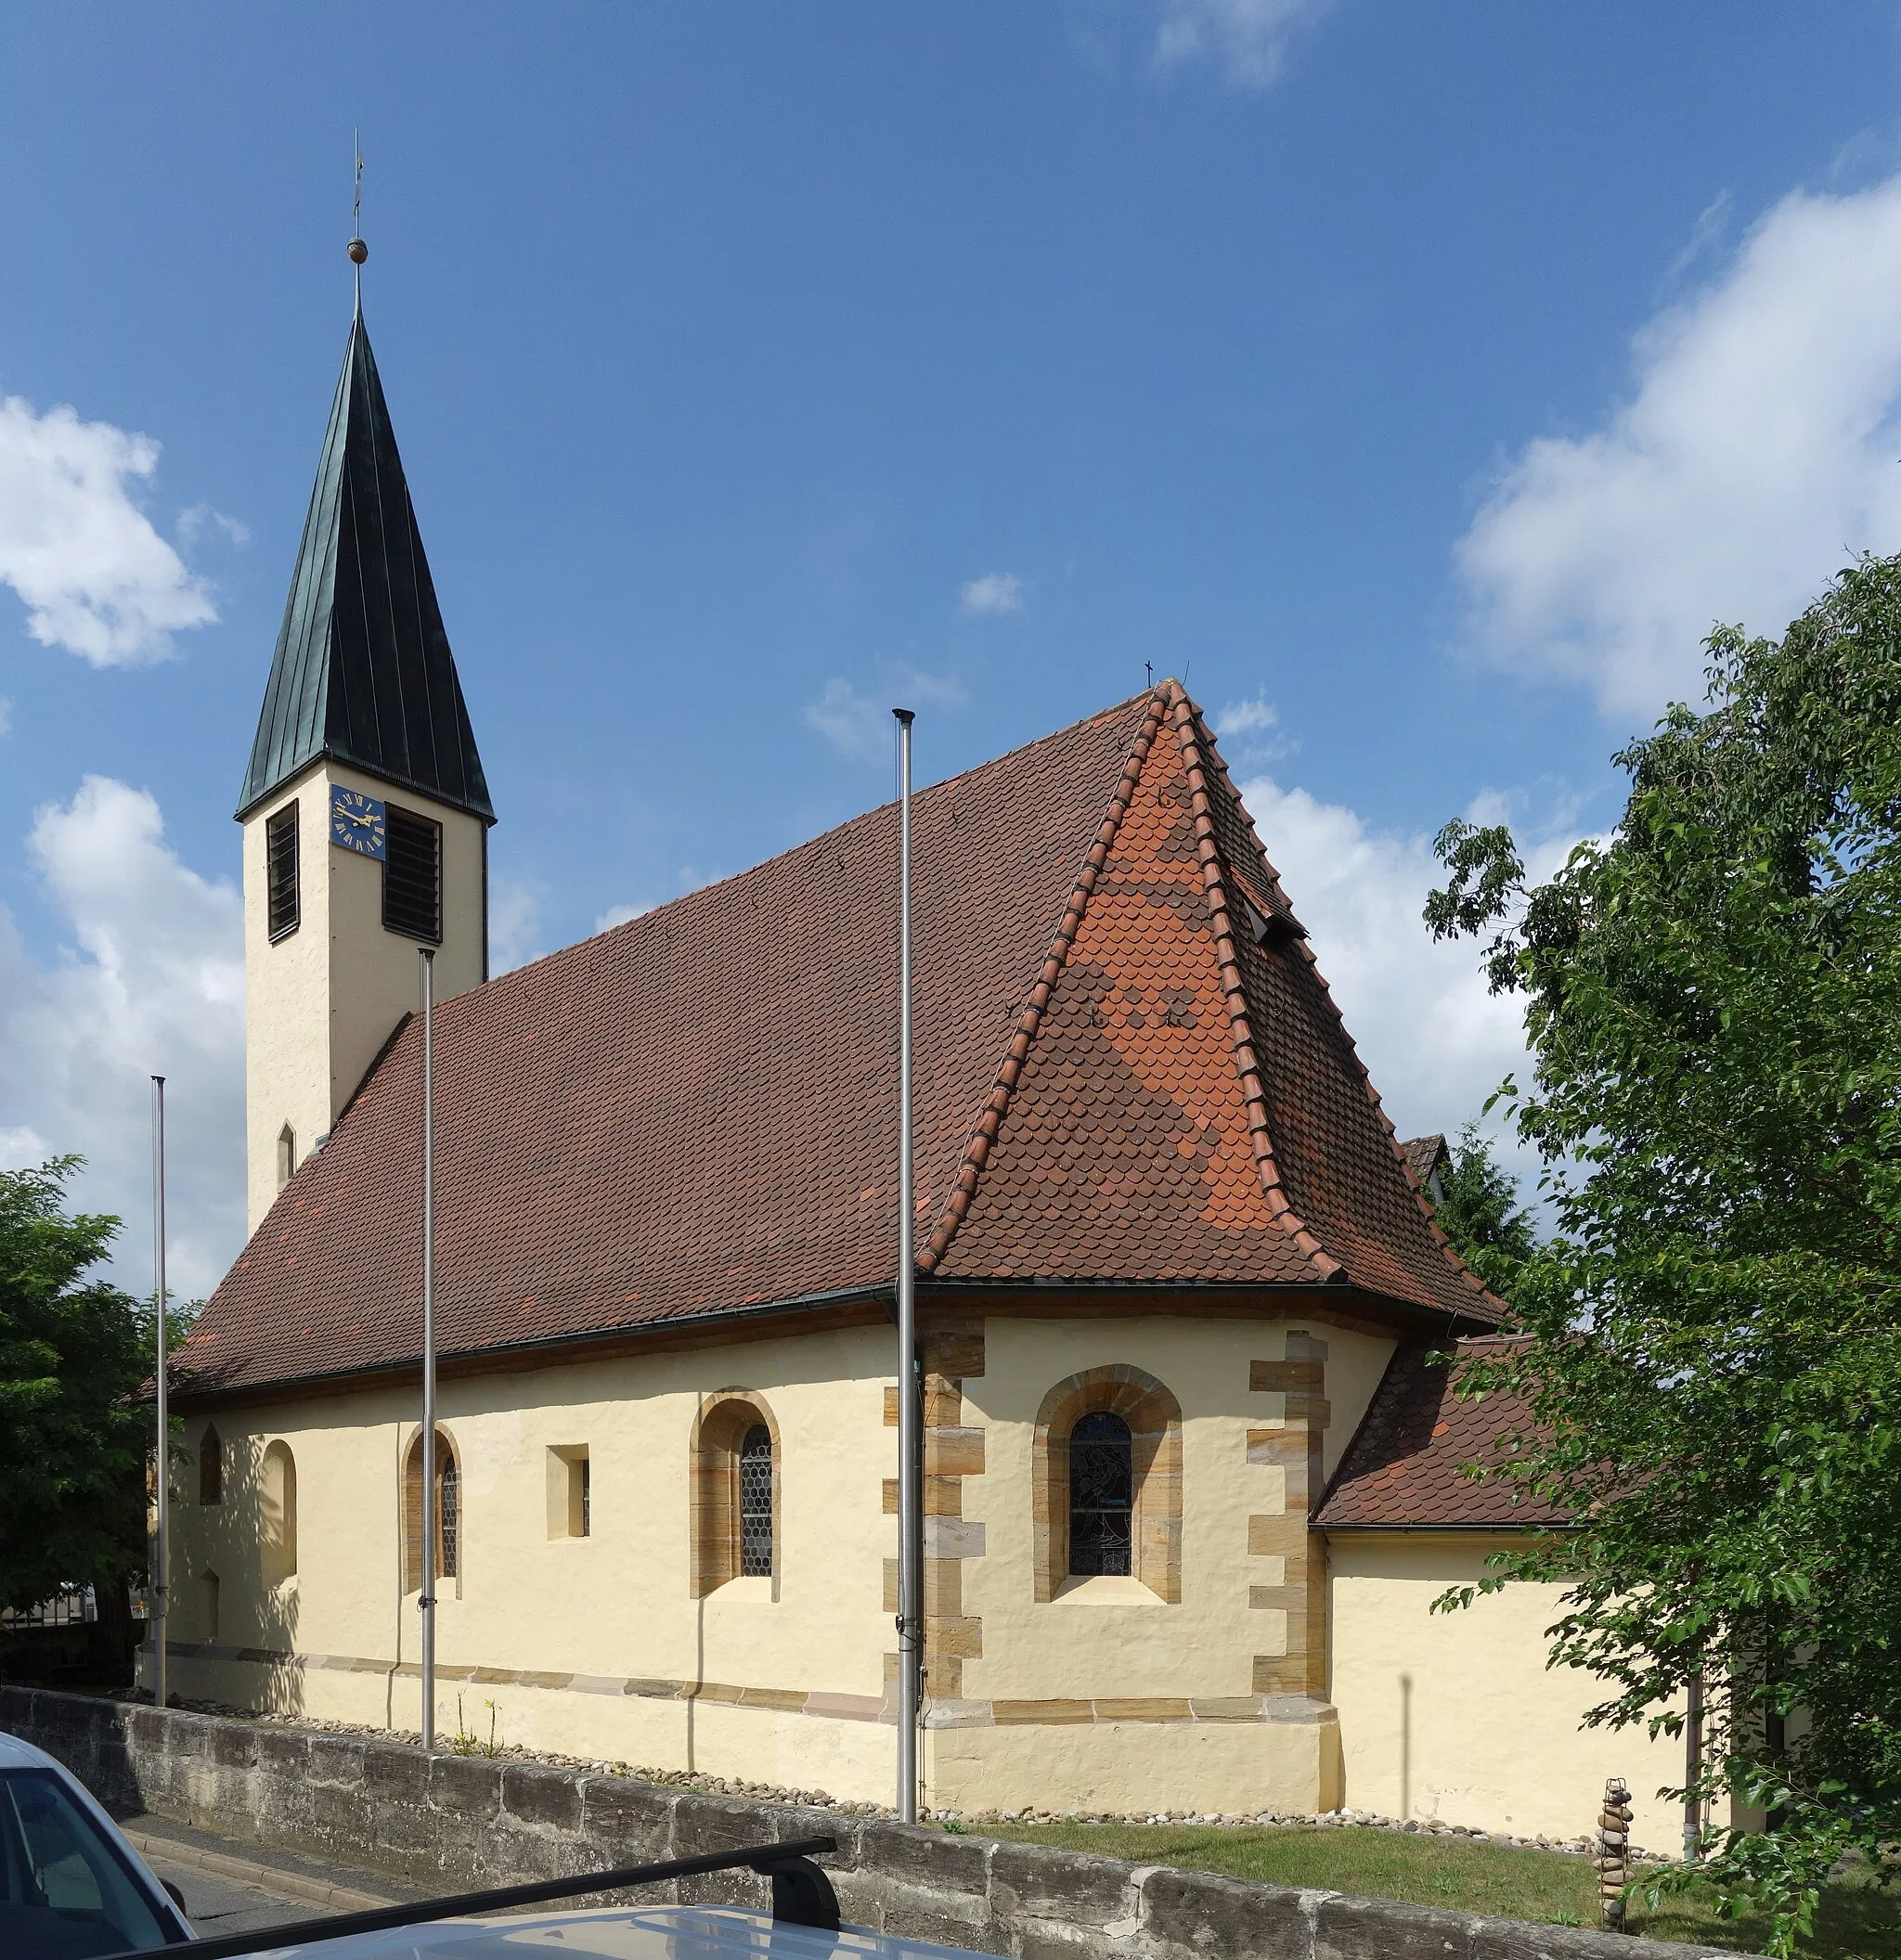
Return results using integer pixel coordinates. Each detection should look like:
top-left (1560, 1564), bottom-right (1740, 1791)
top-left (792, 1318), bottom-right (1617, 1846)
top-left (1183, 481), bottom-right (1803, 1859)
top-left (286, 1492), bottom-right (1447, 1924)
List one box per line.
top-left (243, 763), bottom-right (486, 1231)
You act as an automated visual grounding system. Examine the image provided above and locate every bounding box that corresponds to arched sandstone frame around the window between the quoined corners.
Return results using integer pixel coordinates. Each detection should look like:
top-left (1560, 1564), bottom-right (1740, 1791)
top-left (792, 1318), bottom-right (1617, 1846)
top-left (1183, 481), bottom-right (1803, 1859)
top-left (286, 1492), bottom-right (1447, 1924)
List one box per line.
top-left (1031, 1362), bottom-right (1182, 1605)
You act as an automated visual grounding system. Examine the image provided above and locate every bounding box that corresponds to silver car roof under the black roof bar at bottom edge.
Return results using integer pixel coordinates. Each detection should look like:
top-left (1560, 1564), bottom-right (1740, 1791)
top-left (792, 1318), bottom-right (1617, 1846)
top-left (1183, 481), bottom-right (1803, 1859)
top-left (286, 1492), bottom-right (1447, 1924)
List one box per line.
top-left (254, 1905), bottom-right (991, 1960)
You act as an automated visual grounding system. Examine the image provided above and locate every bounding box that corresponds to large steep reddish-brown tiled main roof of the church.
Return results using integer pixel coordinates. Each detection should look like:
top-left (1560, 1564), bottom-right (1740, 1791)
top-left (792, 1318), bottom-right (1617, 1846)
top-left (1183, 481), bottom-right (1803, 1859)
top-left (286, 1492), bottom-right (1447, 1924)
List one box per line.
top-left (184, 682), bottom-right (1499, 1387)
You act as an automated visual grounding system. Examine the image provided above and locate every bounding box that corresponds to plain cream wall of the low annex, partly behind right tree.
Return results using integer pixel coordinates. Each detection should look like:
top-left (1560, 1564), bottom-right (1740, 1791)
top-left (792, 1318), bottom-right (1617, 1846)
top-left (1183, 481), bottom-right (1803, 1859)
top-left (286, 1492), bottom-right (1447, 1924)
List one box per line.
top-left (1328, 1533), bottom-right (1684, 1852)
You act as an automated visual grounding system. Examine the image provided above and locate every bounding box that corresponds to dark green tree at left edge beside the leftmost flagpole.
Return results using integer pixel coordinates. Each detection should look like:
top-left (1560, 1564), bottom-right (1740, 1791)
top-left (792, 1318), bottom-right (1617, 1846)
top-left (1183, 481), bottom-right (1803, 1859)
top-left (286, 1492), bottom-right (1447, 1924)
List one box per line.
top-left (0, 1156), bottom-right (176, 1621)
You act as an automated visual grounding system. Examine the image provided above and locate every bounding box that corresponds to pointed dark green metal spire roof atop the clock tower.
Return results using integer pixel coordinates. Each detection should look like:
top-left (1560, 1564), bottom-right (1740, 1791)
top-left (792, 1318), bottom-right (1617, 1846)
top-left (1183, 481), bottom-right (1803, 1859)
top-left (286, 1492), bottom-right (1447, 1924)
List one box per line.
top-left (237, 312), bottom-right (496, 823)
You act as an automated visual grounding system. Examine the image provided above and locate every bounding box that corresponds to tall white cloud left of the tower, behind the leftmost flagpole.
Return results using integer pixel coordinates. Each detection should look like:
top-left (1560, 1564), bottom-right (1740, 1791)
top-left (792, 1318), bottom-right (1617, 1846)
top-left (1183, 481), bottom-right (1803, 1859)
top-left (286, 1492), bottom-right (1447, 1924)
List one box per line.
top-left (0, 776), bottom-right (245, 1296)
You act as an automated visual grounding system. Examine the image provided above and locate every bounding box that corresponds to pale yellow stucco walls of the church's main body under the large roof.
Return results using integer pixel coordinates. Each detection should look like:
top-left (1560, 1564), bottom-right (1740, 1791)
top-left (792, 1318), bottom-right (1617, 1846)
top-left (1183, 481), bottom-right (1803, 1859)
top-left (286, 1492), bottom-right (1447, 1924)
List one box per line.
top-left (155, 1317), bottom-right (1390, 1809)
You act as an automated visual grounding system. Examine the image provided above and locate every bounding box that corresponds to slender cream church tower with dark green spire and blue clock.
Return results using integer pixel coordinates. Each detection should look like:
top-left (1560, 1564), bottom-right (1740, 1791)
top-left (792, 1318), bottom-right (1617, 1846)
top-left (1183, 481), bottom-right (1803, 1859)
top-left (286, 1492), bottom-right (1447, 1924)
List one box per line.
top-left (237, 303), bottom-right (496, 1231)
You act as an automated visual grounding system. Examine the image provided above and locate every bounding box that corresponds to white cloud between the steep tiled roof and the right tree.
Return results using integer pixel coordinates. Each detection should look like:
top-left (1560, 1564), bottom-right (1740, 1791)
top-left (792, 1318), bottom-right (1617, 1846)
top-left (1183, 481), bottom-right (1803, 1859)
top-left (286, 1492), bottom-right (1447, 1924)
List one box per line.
top-left (1240, 760), bottom-right (1571, 1168)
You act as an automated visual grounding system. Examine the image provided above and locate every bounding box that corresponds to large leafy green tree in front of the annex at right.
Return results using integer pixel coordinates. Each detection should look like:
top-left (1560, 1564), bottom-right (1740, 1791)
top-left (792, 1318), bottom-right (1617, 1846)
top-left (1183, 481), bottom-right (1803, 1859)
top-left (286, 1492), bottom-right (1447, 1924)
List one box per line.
top-left (1427, 559), bottom-right (1901, 1953)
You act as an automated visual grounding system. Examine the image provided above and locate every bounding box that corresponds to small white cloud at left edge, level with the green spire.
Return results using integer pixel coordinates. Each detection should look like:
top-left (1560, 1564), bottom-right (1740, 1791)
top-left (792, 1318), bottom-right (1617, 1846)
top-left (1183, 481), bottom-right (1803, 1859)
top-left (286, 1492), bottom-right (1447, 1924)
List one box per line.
top-left (0, 396), bottom-right (217, 666)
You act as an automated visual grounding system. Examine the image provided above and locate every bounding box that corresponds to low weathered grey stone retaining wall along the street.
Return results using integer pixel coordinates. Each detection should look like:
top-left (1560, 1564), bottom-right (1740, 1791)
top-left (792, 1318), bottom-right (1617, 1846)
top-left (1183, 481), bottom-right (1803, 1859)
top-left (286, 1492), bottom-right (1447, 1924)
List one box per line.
top-left (0, 1687), bottom-right (1735, 1960)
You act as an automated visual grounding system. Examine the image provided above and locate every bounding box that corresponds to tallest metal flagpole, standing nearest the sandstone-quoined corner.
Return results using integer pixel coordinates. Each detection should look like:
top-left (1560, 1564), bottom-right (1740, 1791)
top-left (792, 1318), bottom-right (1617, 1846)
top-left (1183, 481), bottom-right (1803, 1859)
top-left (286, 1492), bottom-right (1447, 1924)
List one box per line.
top-left (892, 707), bottom-right (923, 1825)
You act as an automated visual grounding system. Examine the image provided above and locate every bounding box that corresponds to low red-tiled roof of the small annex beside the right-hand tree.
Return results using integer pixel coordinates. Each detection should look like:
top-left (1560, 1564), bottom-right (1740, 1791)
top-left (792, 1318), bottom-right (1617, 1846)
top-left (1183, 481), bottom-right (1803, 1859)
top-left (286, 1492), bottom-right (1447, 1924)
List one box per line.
top-left (1313, 1336), bottom-right (1566, 1530)
